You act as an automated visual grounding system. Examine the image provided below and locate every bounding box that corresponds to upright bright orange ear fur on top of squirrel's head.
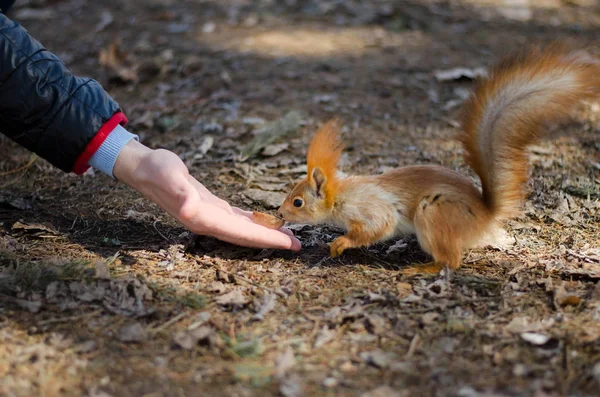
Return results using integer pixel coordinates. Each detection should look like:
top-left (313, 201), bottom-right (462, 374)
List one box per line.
top-left (306, 119), bottom-right (344, 204)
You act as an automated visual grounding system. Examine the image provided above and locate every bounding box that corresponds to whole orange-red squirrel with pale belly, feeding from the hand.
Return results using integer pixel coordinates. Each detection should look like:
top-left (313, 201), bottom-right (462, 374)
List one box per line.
top-left (278, 44), bottom-right (600, 274)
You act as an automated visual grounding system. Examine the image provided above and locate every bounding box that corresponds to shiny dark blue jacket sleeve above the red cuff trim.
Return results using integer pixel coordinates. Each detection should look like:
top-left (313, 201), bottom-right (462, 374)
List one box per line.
top-left (0, 10), bottom-right (120, 172)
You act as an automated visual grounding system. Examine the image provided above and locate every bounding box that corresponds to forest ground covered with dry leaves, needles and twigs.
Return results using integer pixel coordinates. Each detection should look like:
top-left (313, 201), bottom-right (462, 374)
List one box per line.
top-left (0, 0), bottom-right (600, 397)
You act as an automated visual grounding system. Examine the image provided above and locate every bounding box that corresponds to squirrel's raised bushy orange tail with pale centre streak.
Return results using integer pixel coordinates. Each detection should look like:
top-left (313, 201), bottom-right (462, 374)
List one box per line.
top-left (459, 45), bottom-right (600, 219)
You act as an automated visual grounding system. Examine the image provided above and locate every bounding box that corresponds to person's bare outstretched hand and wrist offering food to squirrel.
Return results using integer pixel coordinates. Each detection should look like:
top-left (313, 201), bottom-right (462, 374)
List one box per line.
top-left (113, 140), bottom-right (301, 251)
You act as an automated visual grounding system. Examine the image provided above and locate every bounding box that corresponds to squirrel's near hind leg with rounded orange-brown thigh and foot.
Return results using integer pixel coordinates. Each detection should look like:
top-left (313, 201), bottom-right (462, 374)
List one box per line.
top-left (414, 192), bottom-right (488, 273)
